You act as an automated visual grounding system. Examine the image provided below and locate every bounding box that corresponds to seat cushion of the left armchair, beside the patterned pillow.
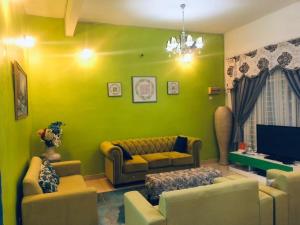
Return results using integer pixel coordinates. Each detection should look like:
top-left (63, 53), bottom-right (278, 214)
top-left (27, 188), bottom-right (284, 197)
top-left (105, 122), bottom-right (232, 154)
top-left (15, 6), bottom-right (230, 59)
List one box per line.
top-left (58, 175), bottom-right (87, 192)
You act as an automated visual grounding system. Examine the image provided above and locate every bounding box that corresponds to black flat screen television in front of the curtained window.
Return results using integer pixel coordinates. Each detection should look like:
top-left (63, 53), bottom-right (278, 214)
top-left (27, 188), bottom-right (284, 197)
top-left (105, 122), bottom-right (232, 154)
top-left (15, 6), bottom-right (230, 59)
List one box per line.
top-left (257, 125), bottom-right (300, 164)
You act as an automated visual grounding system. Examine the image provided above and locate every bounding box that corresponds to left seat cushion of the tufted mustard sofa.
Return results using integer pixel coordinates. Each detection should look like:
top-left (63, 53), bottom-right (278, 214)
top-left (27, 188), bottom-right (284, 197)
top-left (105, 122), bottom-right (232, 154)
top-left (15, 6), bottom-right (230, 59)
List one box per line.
top-left (123, 155), bottom-right (148, 173)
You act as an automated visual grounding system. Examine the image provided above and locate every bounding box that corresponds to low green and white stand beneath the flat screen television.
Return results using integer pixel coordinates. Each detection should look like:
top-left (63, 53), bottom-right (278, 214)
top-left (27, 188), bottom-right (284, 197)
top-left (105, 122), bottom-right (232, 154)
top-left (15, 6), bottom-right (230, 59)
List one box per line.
top-left (229, 151), bottom-right (292, 172)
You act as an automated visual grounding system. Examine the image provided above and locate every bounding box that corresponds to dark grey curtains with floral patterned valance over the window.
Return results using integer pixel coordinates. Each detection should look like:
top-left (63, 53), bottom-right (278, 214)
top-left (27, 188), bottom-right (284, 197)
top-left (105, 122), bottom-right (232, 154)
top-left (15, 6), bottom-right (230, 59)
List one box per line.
top-left (225, 38), bottom-right (300, 149)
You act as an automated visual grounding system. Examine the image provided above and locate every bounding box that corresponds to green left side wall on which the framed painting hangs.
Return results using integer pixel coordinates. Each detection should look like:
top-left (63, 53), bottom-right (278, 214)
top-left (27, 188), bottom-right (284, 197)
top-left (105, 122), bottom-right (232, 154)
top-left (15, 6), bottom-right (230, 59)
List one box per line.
top-left (0, 1), bottom-right (32, 225)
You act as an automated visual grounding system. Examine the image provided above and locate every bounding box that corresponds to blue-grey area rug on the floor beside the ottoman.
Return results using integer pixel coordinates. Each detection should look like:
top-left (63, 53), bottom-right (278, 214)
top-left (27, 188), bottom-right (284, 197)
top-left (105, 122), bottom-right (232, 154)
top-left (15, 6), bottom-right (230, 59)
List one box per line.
top-left (98, 185), bottom-right (146, 225)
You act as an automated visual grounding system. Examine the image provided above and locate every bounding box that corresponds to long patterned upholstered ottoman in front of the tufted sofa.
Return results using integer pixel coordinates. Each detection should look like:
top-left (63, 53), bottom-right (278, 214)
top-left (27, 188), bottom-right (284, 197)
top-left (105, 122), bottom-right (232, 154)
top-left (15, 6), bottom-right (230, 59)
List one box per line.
top-left (145, 167), bottom-right (222, 204)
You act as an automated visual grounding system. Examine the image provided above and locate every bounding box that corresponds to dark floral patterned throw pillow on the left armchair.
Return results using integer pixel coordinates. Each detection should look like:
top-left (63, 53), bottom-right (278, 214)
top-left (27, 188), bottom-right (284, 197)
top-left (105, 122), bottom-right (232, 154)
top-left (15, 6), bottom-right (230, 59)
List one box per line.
top-left (39, 164), bottom-right (57, 193)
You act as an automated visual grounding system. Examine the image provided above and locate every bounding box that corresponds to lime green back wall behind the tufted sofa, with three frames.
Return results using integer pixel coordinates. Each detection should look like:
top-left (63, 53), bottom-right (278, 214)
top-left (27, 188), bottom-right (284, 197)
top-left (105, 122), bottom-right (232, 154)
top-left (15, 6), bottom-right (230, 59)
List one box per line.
top-left (27, 16), bottom-right (224, 174)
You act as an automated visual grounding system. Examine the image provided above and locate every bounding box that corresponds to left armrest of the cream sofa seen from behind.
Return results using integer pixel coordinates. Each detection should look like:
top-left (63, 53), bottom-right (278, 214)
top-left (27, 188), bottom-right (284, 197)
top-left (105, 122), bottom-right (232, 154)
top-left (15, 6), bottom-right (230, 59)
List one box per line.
top-left (124, 191), bottom-right (166, 225)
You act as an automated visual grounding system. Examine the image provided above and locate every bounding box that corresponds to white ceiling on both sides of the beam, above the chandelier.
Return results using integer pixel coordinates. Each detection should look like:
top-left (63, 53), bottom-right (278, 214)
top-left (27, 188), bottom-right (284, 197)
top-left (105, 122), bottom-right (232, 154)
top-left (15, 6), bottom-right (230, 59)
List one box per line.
top-left (25, 0), bottom-right (299, 33)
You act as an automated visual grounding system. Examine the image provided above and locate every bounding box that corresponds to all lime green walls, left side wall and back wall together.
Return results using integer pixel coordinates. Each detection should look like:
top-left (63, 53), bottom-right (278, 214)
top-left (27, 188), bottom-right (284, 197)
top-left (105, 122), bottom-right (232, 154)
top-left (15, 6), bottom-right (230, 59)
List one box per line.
top-left (0, 9), bottom-right (224, 225)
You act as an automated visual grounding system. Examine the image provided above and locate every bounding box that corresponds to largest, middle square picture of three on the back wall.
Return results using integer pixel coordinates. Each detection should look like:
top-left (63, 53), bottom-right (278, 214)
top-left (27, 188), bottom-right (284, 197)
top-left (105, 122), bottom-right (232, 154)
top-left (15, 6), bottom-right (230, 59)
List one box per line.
top-left (132, 76), bottom-right (157, 103)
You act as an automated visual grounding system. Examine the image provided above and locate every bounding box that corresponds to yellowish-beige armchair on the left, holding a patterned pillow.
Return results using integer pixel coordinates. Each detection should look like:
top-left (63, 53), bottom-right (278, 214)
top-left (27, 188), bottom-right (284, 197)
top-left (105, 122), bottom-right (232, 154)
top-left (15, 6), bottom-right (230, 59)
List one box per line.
top-left (22, 157), bottom-right (98, 225)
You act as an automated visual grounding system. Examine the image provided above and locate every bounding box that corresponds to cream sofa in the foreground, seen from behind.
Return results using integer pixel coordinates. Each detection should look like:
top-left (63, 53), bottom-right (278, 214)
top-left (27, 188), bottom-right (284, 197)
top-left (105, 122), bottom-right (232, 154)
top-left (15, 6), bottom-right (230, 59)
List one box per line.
top-left (124, 179), bottom-right (273, 225)
